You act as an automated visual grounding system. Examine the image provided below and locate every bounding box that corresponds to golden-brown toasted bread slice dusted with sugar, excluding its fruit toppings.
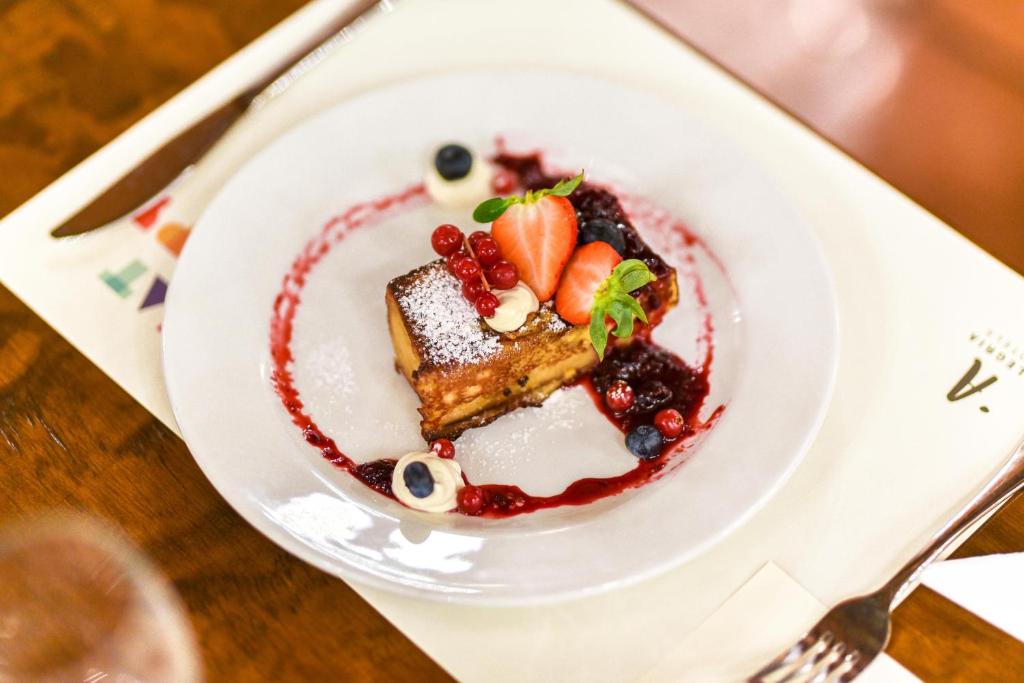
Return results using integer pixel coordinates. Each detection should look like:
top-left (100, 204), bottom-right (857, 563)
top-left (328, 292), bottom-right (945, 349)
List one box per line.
top-left (386, 259), bottom-right (679, 441)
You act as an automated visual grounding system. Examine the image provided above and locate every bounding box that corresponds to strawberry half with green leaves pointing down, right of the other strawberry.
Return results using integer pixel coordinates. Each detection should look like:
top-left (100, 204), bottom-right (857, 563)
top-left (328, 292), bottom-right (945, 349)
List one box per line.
top-left (555, 242), bottom-right (654, 358)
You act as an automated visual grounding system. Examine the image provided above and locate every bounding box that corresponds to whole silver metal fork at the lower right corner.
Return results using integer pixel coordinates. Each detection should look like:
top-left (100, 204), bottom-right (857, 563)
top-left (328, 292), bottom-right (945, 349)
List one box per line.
top-left (746, 441), bottom-right (1024, 683)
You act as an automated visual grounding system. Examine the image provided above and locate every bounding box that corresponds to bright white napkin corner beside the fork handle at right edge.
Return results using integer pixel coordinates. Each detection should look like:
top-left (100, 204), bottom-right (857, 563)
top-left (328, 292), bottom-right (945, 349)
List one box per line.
top-left (923, 553), bottom-right (1024, 641)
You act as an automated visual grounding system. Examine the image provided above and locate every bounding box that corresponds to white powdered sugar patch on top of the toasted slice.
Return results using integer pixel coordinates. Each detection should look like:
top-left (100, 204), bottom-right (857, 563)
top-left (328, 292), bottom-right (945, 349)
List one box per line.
top-left (394, 261), bottom-right (501, 366)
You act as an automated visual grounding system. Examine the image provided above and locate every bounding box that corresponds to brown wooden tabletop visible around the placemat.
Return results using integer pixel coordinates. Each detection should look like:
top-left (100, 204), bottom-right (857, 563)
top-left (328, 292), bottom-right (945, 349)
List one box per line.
top-left (0, 0), bottom-right (1024, 681)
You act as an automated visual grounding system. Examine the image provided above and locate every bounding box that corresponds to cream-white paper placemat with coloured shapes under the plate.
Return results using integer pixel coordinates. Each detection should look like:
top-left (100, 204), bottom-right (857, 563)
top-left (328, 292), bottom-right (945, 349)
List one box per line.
top-left (0, 0), bottom-right (1024, 681)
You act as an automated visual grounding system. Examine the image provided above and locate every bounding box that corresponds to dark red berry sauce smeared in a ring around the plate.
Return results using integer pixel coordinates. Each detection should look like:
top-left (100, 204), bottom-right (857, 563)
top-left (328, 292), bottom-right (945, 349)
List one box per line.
top-left (270, 144), bottom-right (724, 517)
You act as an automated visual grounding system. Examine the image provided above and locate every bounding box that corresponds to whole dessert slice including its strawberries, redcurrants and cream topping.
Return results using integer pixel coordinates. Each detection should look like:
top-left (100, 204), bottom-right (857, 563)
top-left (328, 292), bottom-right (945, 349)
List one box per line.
top-left (386, 167), bottom-right (679, 441)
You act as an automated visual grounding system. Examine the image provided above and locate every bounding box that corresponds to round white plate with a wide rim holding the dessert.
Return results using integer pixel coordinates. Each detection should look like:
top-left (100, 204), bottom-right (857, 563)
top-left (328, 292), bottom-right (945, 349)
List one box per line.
top-left (164, 72), bottom-right (838, 604)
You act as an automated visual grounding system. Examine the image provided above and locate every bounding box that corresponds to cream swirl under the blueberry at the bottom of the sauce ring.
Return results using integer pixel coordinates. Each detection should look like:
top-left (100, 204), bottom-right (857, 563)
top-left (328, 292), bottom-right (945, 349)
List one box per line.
top-left (391, 452), bottom-right (463, 512)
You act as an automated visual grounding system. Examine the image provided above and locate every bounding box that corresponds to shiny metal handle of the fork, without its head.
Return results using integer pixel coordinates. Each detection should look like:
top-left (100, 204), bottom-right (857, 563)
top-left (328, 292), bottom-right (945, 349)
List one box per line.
top-left (879, 441), bottom-right (1024, 605)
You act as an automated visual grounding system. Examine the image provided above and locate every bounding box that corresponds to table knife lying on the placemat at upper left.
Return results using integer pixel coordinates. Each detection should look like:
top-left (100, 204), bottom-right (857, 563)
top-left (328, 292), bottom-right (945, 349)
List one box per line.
top-left (50, 0), bottom-right (391, 238)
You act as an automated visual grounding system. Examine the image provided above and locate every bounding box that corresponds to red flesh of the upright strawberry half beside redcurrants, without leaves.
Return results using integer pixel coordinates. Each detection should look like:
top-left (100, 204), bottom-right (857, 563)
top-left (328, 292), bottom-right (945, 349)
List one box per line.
top-left (490, 195), bottom-right (577, 301)
